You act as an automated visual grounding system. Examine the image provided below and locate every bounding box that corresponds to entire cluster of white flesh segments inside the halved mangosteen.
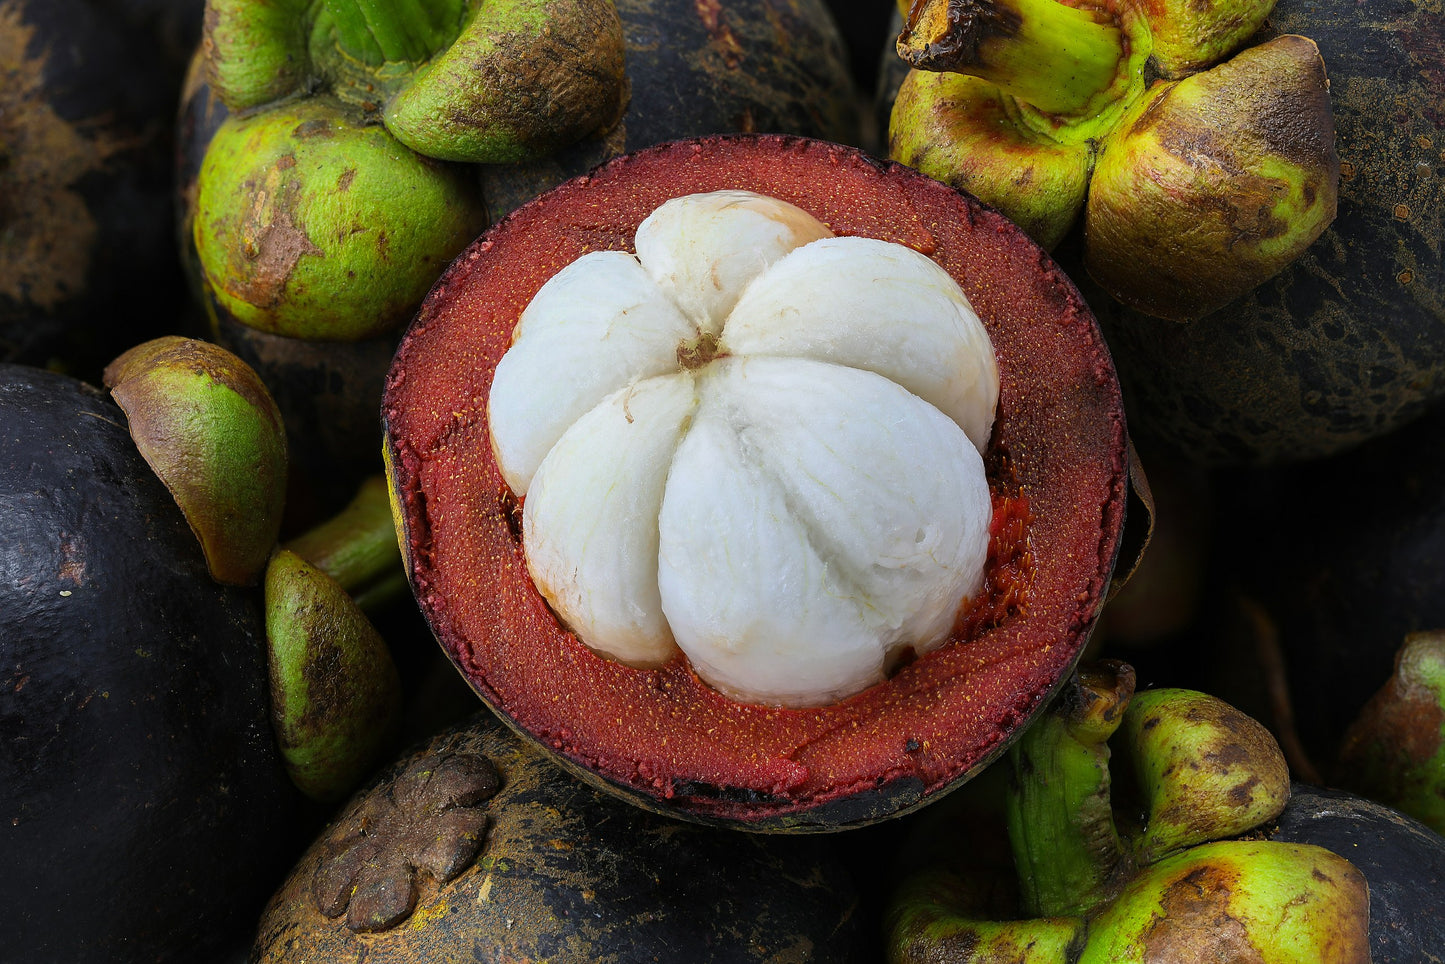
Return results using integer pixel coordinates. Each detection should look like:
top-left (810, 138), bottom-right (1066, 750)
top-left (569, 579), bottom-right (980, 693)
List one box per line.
top-left (488, 192), bottom-right (998, 705)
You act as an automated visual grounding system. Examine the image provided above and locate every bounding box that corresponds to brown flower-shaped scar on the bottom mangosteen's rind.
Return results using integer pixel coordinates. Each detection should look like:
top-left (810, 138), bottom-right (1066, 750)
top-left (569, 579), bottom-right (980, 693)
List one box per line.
top-left (311, 753), bottom-right (501, 932)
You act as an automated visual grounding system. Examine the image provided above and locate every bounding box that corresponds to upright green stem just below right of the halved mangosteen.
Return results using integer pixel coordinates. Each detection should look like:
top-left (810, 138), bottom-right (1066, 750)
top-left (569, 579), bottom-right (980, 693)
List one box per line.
top-left (1006, 662), bottom-right (1134, 918)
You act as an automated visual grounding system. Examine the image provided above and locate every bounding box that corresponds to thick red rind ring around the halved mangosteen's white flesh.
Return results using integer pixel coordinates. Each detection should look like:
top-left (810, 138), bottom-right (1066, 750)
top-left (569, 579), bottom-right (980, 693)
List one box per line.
top-left (383, 136), bottom-right (1129, 830)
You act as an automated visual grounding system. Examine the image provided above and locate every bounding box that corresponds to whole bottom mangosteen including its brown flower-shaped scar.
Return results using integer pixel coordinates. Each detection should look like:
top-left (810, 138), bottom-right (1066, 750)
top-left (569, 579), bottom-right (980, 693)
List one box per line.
top-left (251, 714), bottom-right (876, 964)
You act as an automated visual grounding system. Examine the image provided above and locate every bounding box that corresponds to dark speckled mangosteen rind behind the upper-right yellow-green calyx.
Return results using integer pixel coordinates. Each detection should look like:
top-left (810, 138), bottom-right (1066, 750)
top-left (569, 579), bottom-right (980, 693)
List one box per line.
top-left (1085, 0), bottom-right (1445, 464)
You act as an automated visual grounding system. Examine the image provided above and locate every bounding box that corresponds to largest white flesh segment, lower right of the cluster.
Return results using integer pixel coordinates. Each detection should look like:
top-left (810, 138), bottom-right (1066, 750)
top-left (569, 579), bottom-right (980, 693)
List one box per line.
top-left (657, 357), bottom-right (990, 705)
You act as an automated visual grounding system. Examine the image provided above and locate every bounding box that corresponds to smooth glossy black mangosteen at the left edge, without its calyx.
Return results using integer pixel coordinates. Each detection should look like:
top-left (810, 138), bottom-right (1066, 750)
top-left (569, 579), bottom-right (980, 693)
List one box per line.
top-left (0, 366), bottom-right (301, 963)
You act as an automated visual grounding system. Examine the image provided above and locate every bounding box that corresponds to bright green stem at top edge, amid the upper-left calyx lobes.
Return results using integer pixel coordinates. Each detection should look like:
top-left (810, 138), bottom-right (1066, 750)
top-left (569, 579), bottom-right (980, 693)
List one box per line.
top-left (324, 0), bottom-right (462, 66)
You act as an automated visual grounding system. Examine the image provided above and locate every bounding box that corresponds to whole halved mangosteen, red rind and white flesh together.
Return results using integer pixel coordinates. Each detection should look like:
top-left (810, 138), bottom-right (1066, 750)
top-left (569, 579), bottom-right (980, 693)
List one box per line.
top-left (383, 136), bottom-right (1129, 830)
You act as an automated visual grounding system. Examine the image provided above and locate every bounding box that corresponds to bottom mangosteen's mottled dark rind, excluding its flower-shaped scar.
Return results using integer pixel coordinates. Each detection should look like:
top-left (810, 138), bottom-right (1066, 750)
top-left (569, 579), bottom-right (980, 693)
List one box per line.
top-left (251, 714), bottom-right (873, 964)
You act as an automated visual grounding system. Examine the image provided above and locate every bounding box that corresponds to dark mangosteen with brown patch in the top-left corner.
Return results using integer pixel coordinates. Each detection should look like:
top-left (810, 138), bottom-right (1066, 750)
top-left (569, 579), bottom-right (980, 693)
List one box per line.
top-left (0, 0), bottom-right (201, 380)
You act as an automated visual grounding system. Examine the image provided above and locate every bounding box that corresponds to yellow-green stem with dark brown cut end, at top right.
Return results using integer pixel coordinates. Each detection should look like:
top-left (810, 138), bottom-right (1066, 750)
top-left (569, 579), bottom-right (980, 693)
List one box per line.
top-left (897, 0), bottom-right (1129, 116)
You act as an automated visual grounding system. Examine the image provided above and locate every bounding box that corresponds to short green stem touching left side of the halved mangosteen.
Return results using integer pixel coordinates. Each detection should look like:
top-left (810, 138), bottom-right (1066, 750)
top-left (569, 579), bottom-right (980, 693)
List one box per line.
top-left (286, 475), bottom-right (405, 608)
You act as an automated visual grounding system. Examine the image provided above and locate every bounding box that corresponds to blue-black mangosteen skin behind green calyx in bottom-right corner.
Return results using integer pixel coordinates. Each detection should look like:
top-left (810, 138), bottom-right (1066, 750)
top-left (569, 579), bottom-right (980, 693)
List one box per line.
top-left (1270, 783), bottom-right (1445, 964)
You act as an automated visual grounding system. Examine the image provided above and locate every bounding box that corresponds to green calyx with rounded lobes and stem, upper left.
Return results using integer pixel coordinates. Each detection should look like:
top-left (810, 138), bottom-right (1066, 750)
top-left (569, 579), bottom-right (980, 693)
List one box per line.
top-left (192, 0), bottom-right (627, 341)
